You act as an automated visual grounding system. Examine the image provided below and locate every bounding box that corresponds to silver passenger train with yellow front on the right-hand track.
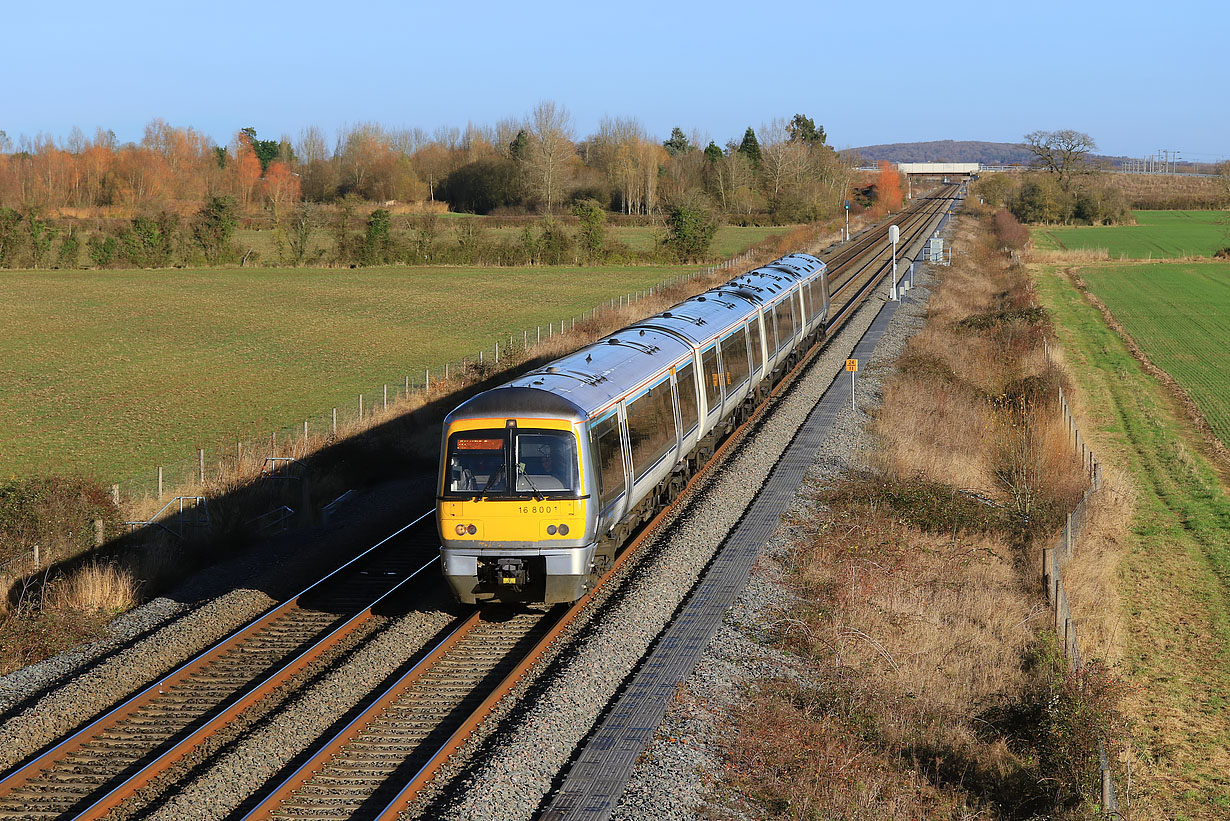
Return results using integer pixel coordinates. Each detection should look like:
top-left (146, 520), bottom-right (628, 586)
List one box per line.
top-left (437, 254), bottom-right (829, 603)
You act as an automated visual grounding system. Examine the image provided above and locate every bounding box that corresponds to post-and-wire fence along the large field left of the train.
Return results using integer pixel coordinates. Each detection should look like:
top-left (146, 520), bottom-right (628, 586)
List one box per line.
top-left (111, 246), bottom-right (765, 521)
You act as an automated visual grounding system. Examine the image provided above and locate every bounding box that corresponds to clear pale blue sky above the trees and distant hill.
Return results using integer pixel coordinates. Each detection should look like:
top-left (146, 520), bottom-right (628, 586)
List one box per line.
top-left (0, 0), bottom-right (1230, 160)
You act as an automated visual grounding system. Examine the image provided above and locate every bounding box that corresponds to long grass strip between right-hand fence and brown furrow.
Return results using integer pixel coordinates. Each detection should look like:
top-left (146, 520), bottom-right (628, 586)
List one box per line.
top-left (1036, 268), bottom-right (1230, 819)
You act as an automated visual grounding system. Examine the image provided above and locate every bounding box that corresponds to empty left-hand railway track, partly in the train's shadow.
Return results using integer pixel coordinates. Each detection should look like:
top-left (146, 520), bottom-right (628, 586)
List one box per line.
top-left (0, 515), bottom-right (437, 819)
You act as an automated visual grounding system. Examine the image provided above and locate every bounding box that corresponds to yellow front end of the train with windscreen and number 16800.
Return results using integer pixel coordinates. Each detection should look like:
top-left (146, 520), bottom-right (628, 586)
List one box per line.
top-left (437, 388), bottom-right (597, 603)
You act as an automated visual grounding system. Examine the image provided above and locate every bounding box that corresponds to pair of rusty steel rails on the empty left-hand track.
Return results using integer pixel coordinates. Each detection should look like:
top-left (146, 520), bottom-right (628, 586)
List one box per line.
top-left (0, 511), bottom-right (435, 819)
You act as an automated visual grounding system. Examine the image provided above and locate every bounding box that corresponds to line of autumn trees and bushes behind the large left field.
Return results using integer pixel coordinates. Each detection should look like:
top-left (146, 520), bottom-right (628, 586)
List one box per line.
top-left (0, 101), bottom-right (852, 267)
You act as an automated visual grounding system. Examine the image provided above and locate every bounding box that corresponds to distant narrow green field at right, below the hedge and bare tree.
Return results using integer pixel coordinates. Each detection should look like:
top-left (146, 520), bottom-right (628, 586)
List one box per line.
top-left (1031, 210), bottom-right (1230, 260)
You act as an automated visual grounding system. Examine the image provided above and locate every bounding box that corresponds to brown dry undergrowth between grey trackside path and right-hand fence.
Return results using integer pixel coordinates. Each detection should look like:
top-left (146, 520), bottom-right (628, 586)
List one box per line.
top-left (711, 214), bottom-right (1121, 819)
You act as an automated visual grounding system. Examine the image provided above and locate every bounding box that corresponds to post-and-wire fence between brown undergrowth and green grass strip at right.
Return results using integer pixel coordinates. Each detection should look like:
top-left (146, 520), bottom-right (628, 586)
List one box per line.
top-left (1042, 376), bottom-right (1121, 819)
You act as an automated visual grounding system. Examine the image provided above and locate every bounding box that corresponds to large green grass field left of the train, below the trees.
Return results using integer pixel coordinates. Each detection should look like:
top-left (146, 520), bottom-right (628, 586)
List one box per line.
top-left (0, 266), bottom-right (690, 481)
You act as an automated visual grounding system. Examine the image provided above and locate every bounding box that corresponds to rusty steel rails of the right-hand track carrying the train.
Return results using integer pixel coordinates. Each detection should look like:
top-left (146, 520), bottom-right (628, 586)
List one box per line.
top-left (244, 185), bottom-right (959, 821)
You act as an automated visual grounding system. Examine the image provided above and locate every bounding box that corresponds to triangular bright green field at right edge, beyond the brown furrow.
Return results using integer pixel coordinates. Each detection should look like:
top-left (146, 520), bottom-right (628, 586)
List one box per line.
top-left (1080, 262), bottom-right (1230, 443)
